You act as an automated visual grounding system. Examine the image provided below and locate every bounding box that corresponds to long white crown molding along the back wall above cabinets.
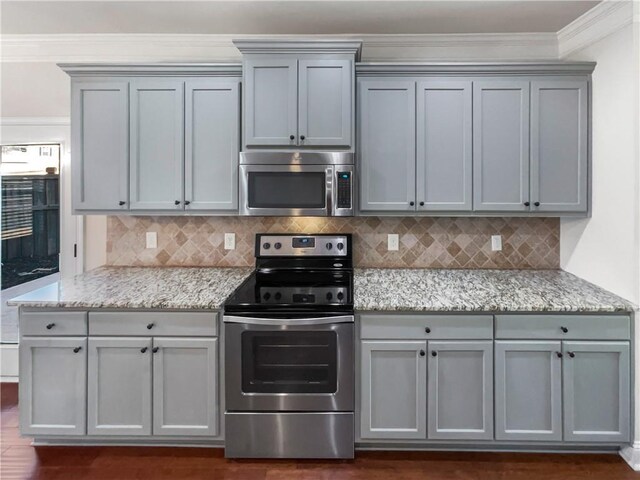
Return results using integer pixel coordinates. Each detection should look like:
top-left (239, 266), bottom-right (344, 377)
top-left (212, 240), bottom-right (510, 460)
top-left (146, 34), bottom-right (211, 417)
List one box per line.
top-left (0, 33), bottom-right (558, 63)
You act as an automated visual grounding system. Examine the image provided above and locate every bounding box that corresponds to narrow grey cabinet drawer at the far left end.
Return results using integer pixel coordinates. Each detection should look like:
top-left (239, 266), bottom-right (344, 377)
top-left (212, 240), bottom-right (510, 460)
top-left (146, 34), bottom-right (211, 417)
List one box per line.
top-left (20, 310), bottom-right (87, 336)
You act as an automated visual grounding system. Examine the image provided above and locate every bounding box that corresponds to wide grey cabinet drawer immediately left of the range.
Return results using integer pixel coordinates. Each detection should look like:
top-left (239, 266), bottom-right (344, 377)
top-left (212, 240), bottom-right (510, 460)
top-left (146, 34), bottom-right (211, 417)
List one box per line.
top-left (89, 311), bottom-right (218, 337)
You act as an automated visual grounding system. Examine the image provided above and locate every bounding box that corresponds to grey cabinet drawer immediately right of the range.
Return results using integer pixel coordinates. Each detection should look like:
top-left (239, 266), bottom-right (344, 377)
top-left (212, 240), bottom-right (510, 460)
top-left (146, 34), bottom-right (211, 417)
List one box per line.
top-left (360, 314), bottom-right (493, 340)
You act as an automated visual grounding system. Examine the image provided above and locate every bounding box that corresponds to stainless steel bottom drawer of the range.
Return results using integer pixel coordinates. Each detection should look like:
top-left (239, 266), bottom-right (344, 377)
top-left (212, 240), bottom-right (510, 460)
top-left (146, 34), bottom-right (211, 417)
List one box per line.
top-left (224, 412), bottom-right (354, 458)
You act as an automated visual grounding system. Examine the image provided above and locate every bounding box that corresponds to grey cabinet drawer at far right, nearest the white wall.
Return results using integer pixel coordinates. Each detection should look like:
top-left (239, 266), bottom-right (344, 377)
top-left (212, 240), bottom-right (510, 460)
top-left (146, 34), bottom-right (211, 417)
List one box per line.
top-left (496, 315), bottom-right (631, 340)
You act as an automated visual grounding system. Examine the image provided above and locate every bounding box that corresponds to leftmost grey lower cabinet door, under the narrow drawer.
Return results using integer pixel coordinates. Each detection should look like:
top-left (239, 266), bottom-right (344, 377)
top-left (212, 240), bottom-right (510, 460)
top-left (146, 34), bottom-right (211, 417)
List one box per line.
top-left (20, 337), bottom-right (87, 436)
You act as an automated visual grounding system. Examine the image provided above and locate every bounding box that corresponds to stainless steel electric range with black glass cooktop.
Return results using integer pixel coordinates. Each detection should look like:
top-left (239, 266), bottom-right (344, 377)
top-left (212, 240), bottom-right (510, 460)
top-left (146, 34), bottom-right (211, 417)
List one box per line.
top-left (224, 234), bottom-right (354, 458)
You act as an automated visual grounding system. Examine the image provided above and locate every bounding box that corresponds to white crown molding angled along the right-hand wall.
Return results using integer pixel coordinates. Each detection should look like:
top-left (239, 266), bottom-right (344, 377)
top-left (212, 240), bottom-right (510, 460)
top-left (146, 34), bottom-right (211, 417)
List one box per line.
top-left (558, 0), bottom-right (638, 58)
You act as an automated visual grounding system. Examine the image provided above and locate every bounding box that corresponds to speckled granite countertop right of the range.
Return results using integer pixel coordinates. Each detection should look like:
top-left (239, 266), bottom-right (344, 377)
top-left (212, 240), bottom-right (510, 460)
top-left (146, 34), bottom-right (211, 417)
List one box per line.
top-left (354, 269), bottom-right (635, 312)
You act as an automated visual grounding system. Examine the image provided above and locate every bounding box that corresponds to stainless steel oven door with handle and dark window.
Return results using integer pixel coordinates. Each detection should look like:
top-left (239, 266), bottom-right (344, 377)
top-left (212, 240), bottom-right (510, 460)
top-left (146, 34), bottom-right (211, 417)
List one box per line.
top-left (224, 316), bottom-right (354, 412)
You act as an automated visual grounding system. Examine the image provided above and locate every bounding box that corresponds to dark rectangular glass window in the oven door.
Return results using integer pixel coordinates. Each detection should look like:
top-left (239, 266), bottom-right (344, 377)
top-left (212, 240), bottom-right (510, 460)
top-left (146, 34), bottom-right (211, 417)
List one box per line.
top-left (242, 331), bottom-right (338, 393)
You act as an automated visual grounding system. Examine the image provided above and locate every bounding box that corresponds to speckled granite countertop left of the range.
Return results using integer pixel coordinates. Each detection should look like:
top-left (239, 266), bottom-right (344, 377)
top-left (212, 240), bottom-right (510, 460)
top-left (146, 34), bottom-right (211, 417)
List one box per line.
top-left (8, 267), bottom-right (252, 310)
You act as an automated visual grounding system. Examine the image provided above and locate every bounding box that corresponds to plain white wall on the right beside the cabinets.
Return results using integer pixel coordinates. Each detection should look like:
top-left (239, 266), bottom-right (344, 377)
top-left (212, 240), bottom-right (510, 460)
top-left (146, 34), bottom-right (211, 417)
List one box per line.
top-left (560, 23), bottom-right (640, 304)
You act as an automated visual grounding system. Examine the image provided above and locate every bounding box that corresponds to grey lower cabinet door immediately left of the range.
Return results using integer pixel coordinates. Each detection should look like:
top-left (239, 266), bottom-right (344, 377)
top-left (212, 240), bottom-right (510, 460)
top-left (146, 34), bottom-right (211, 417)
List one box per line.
top-left (153, 338), bottom-right (219, 436)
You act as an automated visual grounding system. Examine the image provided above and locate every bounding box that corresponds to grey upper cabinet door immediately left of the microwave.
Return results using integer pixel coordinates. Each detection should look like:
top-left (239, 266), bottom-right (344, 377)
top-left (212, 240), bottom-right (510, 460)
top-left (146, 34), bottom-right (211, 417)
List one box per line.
top-left (185, 79), bottom-right (240, 212)
